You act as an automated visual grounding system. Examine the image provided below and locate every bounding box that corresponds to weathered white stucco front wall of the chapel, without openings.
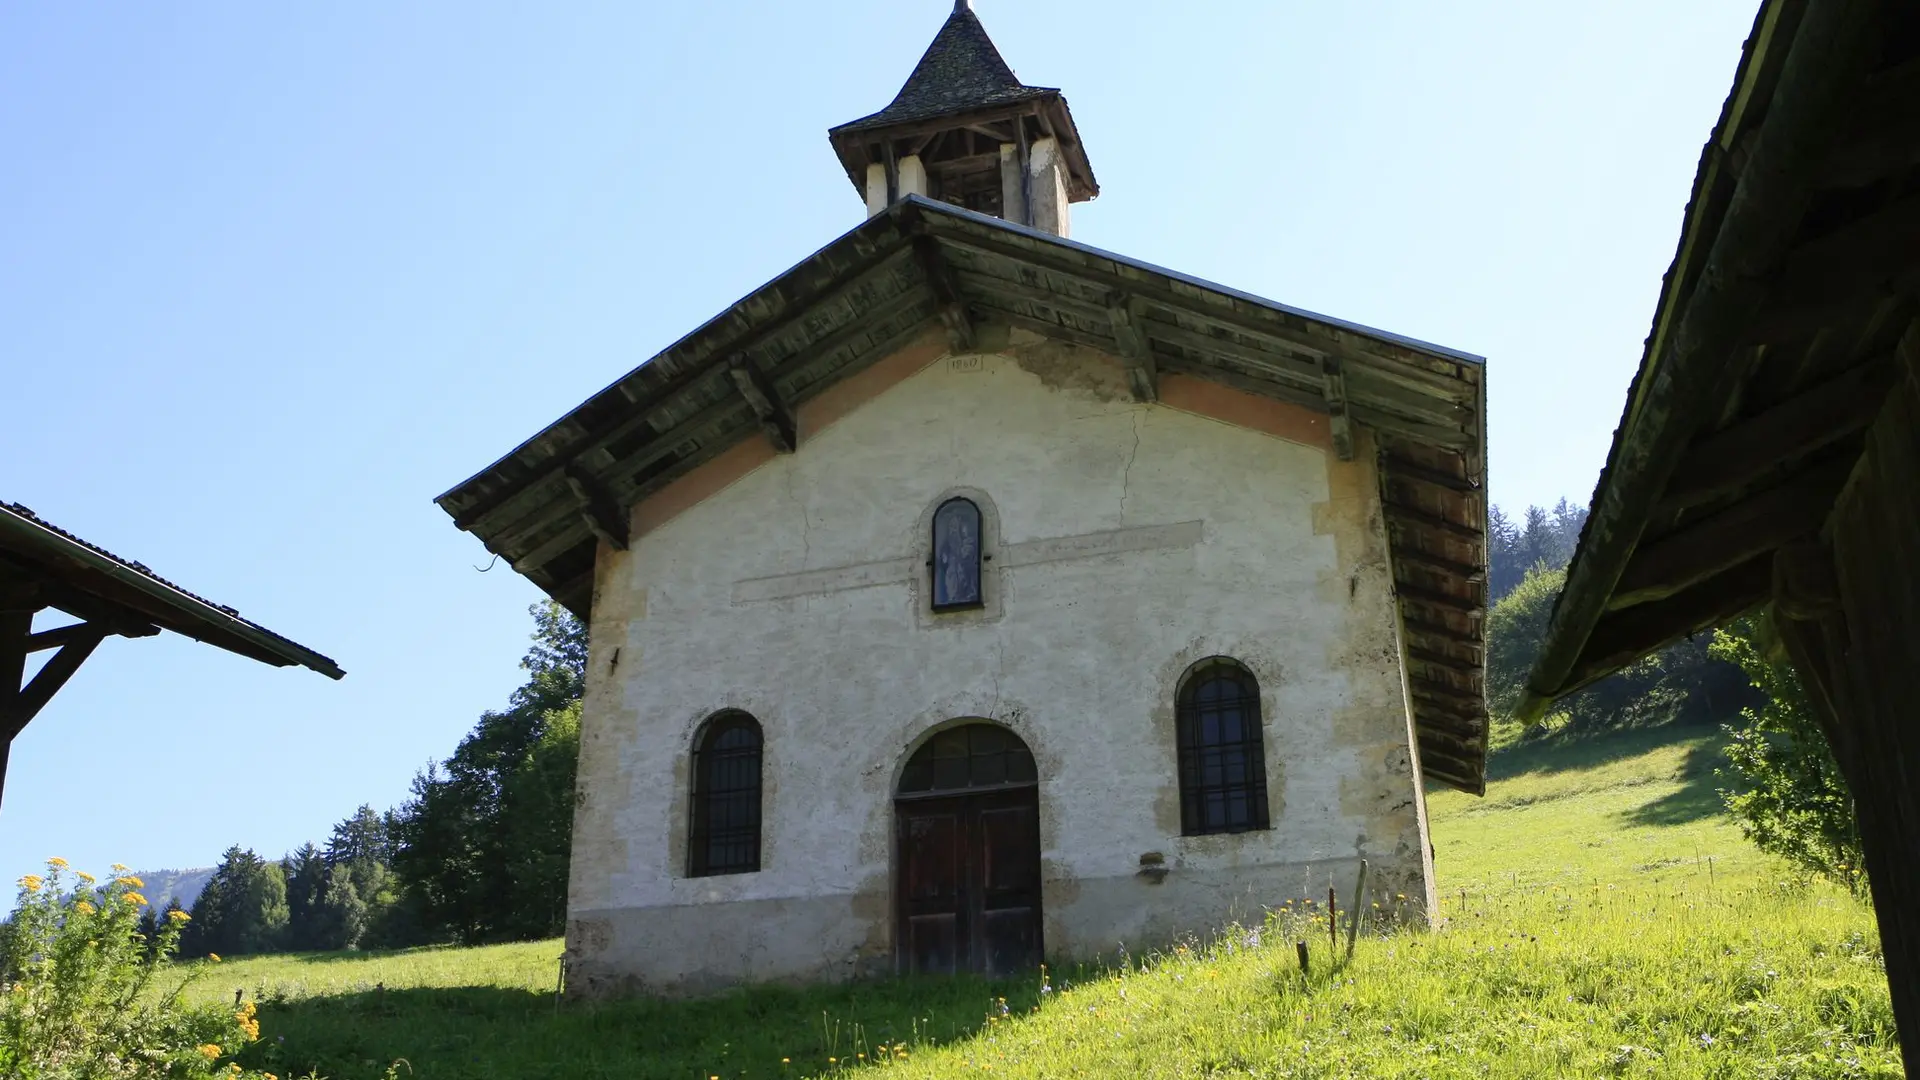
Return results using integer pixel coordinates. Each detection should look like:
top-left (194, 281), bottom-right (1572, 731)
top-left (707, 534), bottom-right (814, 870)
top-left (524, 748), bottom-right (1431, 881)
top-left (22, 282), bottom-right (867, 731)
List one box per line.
top-left (568, 334), bottom-right (1432, 994)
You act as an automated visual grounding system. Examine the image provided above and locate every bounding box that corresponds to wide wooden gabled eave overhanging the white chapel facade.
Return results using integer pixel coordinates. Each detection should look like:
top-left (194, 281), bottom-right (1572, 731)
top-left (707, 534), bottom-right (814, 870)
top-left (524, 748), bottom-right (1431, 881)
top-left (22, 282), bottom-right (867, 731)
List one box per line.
top-left (436, 196), bottom-right (1486, 794)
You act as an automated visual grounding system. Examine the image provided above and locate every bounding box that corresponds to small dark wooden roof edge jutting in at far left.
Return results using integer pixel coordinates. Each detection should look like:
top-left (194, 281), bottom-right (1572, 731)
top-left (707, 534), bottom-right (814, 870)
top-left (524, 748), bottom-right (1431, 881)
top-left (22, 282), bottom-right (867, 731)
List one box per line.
top-left (0, 503), bottom-right (346, 678)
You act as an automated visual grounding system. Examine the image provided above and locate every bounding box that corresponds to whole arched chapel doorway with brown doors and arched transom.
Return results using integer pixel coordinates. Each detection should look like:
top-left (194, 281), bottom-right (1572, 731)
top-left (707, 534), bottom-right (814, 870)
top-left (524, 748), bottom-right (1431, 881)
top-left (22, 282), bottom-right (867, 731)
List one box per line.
top-left (895, 723), bottom-right (1043, 974)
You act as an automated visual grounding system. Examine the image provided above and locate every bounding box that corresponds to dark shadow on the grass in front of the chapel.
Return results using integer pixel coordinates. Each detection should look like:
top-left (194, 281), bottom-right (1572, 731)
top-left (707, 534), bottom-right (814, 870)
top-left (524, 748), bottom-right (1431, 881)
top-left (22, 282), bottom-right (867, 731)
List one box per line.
top-left (240, 976), bottom-right (1039, 1080)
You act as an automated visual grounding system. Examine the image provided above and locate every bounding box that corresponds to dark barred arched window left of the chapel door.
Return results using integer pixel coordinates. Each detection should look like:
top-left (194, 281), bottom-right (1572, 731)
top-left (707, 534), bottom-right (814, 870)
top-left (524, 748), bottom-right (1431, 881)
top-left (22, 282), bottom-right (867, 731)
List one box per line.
top-left (687, 713), bottom-right (760, 878)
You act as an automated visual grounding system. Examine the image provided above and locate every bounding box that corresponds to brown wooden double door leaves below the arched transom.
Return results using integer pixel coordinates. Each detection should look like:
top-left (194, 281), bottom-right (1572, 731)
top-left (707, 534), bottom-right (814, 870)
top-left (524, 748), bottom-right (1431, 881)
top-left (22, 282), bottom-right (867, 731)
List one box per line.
top-left (895, 784), bottom-right (1041, 976)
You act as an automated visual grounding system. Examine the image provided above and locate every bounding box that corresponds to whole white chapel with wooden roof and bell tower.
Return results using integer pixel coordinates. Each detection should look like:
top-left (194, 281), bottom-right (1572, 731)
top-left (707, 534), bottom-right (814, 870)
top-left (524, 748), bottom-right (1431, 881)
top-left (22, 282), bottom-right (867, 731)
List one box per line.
top-left (438, 0), bottom-right (1486, 995)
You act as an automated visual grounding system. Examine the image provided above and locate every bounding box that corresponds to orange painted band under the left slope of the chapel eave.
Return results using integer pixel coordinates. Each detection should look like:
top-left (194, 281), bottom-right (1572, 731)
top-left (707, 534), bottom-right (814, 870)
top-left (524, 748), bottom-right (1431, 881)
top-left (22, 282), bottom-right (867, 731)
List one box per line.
top-left (628, 332), bottom-right (947, 540)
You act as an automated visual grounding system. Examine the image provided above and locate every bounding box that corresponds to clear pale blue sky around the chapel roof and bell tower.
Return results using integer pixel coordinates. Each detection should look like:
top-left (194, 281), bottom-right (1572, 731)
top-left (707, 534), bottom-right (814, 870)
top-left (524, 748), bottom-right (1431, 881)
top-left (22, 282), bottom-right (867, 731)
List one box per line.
top-left (0, 0), bottom-right (1755, 880)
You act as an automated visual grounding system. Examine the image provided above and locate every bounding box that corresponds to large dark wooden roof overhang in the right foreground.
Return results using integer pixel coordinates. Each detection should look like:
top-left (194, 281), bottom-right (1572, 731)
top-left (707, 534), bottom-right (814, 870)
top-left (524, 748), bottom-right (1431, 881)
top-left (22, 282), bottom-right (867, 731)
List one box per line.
top-left (1521, 0), bottom-right (1920, 719)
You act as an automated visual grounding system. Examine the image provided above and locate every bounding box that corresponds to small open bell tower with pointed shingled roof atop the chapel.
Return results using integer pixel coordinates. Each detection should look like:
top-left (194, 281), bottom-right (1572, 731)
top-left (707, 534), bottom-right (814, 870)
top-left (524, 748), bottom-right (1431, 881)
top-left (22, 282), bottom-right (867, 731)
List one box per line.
top-left (828, 0), bottom-right (1100, 236)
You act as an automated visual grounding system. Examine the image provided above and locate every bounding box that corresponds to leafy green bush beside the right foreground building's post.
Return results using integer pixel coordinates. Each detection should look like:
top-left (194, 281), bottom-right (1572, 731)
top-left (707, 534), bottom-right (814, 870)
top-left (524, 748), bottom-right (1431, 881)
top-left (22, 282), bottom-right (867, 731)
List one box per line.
top-left (1713, 619), bottom-right (1866, 892)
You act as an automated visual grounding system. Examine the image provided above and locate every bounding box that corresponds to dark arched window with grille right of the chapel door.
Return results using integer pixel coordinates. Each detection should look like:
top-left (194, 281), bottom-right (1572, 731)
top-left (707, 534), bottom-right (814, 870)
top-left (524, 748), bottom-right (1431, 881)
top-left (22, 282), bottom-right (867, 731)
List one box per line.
top-left (1175, 657), bottom-right (1267, 836)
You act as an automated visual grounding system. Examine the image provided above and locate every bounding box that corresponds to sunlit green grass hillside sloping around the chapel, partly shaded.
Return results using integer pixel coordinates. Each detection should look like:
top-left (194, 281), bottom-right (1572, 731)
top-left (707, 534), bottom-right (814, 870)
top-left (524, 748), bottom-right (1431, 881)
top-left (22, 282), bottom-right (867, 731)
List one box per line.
top-left (190, 730), bottom-right (1899, 1080)
